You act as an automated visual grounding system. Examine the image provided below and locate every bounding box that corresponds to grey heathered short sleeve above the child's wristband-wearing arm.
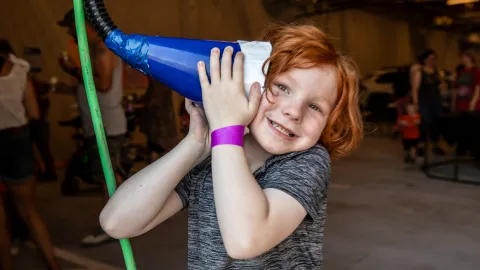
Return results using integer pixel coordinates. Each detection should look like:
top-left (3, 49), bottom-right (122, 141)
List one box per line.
top-left (261, 146), bottom-right (331, 220)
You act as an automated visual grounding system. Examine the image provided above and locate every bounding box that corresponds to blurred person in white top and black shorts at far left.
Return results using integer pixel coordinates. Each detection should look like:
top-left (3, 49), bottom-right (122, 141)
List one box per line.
top-left (0, 40), bottom-right (60, 270)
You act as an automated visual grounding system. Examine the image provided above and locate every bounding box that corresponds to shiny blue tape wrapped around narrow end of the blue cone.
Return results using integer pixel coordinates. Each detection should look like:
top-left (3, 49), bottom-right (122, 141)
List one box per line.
top-left (105, 29), bottom-right (150, 76)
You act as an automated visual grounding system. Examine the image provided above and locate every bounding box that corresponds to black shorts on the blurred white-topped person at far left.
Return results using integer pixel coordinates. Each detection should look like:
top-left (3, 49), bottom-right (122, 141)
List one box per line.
top-left (0, 126), bottom-right (35, 184)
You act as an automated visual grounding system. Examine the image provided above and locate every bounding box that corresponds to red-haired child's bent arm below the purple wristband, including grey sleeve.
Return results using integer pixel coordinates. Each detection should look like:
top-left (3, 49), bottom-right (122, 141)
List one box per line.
top-left (212, 148), bottom-right (328, 259)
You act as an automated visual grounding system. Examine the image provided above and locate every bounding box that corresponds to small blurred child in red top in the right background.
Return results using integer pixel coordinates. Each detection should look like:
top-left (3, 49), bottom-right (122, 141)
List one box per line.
top-left (399, 103), bottom-right (420, 164)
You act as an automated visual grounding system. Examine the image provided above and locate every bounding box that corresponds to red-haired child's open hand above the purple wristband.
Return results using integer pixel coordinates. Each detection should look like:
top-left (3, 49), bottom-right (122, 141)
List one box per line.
top-left (198, 46), bottom-right (261, 132)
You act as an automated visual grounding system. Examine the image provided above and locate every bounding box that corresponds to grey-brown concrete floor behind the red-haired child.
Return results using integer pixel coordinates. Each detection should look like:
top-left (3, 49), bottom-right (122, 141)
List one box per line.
top-left (10, 137), bottom-right (480, 270)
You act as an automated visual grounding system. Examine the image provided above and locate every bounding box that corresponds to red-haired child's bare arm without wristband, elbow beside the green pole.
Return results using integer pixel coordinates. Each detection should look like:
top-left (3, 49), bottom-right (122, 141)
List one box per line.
top-left (100, 101), bottom-right (210, 239)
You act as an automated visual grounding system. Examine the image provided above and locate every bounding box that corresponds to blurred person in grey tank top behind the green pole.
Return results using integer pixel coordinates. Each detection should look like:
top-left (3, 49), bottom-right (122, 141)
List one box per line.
top-left (58, 9), bottom-right (127, 247)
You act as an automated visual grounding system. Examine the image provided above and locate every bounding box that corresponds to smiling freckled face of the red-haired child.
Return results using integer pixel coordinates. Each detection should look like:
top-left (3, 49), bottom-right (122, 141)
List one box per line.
top-left (250, 67), bottom-right (337, 155)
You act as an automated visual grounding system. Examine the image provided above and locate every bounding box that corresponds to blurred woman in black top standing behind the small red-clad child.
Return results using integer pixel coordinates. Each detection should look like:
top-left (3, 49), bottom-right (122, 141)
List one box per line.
top-left (412, 49), bottom-right (442, 155)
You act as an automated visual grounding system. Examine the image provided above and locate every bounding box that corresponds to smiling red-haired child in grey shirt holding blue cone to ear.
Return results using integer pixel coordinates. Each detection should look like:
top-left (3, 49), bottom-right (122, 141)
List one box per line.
top-left (100, 26), bottom-right (363, 269)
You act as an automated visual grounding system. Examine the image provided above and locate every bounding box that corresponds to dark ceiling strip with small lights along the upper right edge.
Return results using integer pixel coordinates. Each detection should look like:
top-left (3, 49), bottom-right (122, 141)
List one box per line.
top-left (263, 0), bottom-right (480, 33)
